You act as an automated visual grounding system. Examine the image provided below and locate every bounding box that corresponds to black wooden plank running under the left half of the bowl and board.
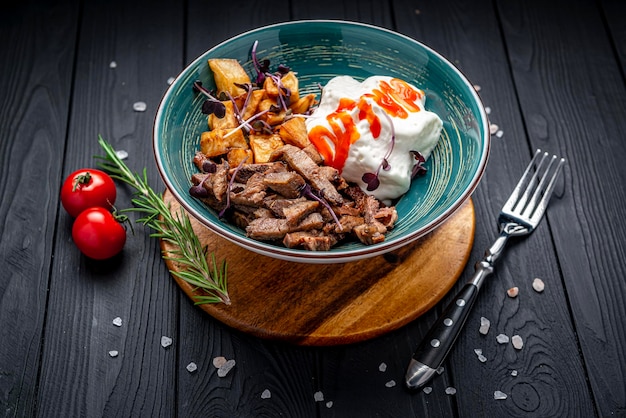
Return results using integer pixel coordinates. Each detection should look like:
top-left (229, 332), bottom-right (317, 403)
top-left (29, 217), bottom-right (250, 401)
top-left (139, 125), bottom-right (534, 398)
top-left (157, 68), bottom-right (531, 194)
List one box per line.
top-left (178, 4), bottom-right (318, 417)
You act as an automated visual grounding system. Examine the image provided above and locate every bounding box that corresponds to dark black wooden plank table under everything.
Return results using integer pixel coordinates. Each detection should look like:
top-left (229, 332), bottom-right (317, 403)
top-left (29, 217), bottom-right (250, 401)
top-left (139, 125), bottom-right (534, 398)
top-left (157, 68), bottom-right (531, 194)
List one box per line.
top-left (0, 0), bottom-right (626, 417)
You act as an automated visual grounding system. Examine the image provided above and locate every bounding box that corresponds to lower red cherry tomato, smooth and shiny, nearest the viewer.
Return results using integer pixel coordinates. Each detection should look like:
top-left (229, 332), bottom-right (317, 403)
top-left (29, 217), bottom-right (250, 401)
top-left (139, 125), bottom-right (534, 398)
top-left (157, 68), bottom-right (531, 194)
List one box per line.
top-left (72, 207), bottom-right (126, 260)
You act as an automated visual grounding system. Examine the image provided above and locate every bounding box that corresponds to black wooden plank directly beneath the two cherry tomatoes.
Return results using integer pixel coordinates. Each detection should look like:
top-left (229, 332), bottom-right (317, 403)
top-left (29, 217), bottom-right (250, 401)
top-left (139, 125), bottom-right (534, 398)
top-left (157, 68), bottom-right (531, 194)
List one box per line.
top-left (38, 1), bottom-right (183, 416)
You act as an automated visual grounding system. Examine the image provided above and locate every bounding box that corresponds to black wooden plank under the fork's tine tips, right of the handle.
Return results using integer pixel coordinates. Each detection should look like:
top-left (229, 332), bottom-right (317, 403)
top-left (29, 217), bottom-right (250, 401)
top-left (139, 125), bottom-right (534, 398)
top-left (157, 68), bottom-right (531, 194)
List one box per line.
top-left (494, 0), bottom-right (626, 416)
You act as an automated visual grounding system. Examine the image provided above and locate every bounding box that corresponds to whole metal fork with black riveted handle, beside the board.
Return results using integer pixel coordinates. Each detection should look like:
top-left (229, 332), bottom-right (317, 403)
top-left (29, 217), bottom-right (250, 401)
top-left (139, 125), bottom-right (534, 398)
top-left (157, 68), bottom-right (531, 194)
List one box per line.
top-left (405, 150), bottom-right (565, 389)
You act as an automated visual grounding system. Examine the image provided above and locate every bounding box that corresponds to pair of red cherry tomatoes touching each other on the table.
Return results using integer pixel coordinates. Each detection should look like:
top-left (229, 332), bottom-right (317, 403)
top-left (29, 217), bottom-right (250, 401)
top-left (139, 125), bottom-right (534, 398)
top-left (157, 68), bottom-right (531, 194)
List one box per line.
top-left (61, 169), bottom-right (126, 260)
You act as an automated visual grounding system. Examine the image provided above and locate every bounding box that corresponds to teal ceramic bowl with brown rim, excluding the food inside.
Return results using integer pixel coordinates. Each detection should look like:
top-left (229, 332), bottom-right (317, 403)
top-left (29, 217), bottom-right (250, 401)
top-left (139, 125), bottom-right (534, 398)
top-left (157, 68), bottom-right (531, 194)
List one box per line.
top-left (153, 20), bottom-right (490, 263)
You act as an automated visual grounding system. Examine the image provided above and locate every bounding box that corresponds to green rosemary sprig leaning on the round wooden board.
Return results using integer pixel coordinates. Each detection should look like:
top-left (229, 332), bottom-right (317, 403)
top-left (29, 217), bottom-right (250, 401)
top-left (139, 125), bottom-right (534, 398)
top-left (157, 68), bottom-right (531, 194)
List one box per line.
top-left (97, 136), bottom-right (230, 305)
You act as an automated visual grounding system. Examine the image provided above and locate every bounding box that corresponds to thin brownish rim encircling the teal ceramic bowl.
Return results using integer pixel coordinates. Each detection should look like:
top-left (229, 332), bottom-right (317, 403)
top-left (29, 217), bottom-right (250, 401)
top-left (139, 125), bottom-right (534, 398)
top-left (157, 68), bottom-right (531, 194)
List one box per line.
top-left (152, 19), bottom-right (491, 264)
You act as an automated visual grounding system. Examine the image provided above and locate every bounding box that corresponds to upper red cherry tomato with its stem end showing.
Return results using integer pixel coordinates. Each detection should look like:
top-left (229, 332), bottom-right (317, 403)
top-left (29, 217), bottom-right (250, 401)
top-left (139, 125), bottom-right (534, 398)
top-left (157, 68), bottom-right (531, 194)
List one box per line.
top-left (61, 168), bottom-right (117, 218)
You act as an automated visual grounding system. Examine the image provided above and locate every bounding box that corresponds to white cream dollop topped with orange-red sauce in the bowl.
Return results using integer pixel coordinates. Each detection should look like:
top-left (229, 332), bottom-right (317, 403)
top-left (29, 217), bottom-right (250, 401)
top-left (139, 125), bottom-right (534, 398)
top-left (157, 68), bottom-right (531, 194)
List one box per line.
top-left (306, 76), bottom-right (443, 201)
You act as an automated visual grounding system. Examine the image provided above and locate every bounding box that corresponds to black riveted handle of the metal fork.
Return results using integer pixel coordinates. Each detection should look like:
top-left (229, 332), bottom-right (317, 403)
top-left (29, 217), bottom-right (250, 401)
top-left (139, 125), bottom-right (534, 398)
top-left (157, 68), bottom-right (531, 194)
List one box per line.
top-left (405, 257), bottom-right (493, 389)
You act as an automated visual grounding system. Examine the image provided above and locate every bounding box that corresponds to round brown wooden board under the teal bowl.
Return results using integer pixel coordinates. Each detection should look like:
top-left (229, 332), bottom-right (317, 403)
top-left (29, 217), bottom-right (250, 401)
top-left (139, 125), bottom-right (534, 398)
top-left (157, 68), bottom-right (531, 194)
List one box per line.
top-left (161, 191), bottom-right (475, 346)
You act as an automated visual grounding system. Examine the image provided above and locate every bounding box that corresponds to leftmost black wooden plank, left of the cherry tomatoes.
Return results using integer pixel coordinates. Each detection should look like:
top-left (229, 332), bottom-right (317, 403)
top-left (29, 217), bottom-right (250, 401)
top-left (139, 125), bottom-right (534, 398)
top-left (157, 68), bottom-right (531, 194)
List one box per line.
top-left (0, 1), bottom-right (77, 417)
